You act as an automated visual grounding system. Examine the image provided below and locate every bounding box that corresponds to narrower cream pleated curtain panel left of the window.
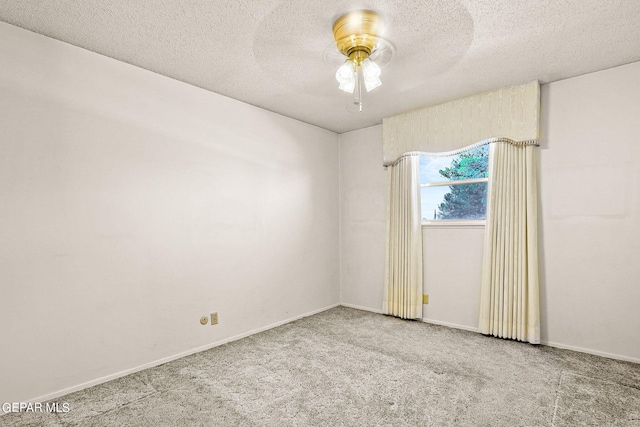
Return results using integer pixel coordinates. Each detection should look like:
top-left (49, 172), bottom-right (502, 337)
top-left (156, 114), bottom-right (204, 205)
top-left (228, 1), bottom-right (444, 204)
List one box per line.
top-left (382, 156), bottom-right (422, 319)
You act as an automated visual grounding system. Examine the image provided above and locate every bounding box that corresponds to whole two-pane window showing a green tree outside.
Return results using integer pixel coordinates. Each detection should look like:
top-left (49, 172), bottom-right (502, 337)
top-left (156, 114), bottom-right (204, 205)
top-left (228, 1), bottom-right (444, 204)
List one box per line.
top-left (420, 145), bottom-right (489, 223)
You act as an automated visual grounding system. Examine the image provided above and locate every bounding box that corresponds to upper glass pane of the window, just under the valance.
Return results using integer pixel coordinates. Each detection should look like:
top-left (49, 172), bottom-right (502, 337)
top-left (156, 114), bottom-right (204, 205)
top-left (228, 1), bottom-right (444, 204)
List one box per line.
top-left (420, 145), bottom-right (489, 184)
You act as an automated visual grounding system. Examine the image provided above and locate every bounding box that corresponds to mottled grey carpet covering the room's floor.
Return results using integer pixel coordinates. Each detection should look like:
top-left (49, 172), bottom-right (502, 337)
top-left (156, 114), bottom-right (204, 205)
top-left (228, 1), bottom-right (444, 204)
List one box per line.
top-left (5, 307), bottom-right (640, 427)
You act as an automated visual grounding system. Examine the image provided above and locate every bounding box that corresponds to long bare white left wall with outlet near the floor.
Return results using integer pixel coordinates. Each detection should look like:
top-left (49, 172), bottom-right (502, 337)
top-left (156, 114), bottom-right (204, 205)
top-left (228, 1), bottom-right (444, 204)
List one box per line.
top-left (0, 23), bottom-right (340, 402)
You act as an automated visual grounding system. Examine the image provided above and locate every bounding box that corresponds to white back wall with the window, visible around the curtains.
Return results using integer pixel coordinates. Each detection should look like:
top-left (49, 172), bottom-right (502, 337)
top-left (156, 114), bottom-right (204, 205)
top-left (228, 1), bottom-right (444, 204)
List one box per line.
top-left (340, 59), bottom-right (640, 362)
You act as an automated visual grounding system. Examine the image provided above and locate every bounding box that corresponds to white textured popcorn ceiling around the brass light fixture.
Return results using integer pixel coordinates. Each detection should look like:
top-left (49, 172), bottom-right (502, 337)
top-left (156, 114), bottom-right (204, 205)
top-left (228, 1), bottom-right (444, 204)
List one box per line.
top-left (0, 0), bottom-right (640, 133)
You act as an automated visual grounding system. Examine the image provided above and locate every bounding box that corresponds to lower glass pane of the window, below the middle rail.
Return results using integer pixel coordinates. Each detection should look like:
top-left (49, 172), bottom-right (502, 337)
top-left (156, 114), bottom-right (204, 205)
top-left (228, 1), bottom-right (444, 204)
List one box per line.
top-left (420, 182), bottom-right (487, 221)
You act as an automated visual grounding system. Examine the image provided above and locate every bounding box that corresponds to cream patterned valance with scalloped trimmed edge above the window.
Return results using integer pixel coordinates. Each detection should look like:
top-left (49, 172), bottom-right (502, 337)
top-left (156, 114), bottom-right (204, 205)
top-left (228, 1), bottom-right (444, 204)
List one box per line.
top-left (382, 81), bottom-right (540, 164)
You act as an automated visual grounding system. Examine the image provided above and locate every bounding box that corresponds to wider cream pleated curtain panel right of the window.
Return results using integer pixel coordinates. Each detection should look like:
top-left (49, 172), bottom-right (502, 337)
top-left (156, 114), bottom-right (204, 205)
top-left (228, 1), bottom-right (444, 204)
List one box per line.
top-left (480, 143), bottom-right (540, 344)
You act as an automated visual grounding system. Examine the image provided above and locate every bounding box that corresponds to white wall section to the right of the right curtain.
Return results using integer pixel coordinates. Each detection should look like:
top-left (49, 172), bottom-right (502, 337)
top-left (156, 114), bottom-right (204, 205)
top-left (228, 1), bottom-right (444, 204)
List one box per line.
top-left (540, 62), bottom-right (640, 362)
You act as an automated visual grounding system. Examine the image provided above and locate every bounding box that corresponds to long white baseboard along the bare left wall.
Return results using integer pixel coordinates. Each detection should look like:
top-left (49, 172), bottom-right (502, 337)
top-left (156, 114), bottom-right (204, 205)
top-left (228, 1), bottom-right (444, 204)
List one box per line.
top-left (23, 304), bottom-right (340, 406)
